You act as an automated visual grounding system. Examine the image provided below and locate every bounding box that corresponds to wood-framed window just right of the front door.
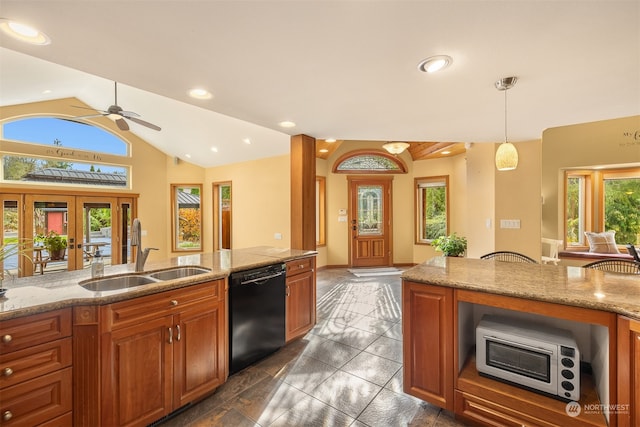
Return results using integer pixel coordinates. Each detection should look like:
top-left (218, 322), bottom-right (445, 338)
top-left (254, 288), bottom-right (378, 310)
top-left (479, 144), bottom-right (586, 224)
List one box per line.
top-left (415, 176), bottom-right (449, 243)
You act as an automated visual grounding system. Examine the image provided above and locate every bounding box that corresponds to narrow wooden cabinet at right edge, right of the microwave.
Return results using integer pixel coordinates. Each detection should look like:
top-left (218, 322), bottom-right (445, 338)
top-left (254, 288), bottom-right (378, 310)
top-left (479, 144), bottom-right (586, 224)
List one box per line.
top-left (617, 316), bottom-right (640, 427)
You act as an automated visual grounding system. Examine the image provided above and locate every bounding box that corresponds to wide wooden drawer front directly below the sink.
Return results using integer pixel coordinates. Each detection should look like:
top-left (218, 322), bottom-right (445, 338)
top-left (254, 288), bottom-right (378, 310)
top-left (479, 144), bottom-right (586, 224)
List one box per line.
top-left (100, 280), bottom-right (224, 332)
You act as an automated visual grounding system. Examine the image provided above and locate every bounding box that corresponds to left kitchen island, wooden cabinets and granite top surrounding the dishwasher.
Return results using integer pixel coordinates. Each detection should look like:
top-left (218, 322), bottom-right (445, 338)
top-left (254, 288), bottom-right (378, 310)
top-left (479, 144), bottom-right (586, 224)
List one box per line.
top-left (0, 247), bottom-right (316, 426)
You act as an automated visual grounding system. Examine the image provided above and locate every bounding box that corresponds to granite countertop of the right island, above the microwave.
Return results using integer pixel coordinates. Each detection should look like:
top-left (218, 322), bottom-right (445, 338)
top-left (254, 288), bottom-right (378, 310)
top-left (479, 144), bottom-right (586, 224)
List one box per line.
top-left (402, 257), bottom-right (640, 320)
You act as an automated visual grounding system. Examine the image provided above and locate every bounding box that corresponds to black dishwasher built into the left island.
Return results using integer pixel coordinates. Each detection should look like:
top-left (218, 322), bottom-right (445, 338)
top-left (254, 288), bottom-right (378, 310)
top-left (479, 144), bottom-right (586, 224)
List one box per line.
top-left (229, 264), bottom-right (286, 374)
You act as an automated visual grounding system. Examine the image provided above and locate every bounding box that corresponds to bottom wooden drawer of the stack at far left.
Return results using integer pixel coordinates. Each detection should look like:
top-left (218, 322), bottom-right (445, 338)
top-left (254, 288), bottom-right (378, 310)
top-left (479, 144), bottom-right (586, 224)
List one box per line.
top-left (0, 368), bottom-right (73, 426)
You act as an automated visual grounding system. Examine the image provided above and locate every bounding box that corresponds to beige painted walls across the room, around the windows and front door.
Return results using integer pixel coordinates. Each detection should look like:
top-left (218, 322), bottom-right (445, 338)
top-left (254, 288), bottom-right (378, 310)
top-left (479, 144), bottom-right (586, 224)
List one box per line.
top-left (0, 98), bottom-right (640, 267)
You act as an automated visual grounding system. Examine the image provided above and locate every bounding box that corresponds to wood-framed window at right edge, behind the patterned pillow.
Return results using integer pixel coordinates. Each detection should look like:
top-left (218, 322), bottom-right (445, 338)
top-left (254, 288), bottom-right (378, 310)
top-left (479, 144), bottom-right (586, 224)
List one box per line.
top-left (564, 168), bottom-right (640, 249)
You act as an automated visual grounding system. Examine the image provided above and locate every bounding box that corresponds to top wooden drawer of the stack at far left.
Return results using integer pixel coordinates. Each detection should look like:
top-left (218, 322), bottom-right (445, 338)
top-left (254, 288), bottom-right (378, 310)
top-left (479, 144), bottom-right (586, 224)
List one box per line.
top-left (0, 309), bottom-right (71, 354)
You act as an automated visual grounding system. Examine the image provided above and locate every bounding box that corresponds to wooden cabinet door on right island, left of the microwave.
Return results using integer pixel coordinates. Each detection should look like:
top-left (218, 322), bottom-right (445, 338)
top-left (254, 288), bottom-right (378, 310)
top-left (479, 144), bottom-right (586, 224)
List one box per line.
top-left (402, 282), bottom-right (453, 410)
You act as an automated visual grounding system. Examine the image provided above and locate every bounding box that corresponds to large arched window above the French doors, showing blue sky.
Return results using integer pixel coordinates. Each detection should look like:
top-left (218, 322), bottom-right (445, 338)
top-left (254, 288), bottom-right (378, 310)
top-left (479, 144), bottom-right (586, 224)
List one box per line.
top-left (0, 117), bottom-right (131, 188)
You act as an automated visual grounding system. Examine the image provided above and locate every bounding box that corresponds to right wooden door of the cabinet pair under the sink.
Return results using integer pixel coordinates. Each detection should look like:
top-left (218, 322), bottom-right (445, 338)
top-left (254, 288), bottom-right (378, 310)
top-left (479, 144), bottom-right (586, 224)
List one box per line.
top-left (174, 303), bottom-right (226, 409)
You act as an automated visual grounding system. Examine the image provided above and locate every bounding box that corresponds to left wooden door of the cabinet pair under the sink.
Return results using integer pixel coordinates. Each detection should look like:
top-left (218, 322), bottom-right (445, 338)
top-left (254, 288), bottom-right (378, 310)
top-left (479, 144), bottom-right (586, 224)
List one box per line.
top-left (102, 316), bottom-right (175, 426)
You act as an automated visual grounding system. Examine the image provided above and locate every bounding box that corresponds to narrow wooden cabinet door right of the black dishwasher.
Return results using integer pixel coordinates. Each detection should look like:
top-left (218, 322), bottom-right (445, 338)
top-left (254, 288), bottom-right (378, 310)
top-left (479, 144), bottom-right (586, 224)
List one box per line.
top-left (286, 271), bottom-right (316, 342)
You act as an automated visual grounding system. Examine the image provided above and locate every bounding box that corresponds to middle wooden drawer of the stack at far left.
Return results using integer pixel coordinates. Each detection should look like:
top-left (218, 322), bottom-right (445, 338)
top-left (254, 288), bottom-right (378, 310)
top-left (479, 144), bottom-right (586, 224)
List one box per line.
top-left (0, 338), bottom-right (71, 389)
